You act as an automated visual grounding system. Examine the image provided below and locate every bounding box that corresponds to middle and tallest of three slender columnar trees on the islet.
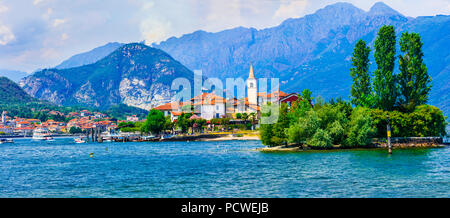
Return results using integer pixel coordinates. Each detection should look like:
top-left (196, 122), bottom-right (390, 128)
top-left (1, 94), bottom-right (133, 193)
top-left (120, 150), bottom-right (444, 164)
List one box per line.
top-left (373, 26), bottom-right (398, 111)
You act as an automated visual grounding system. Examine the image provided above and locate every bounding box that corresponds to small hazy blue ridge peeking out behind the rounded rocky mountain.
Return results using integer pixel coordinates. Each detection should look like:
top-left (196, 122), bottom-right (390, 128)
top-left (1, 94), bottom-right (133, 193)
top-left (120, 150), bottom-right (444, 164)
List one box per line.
top-left (55, 42), bottom-right (124, 69)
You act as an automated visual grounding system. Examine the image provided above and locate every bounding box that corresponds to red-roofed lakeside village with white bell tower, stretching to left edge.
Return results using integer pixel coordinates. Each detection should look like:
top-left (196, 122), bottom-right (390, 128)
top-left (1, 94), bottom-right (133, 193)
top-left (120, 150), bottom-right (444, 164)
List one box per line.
top-left (0, 65), bottom-right (299, 143)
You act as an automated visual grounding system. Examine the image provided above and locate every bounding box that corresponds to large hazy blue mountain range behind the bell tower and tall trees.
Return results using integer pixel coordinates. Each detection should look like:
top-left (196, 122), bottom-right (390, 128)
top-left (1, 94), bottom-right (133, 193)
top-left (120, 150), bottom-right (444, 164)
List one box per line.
top-left (153, 2), bottom-right (450, 115)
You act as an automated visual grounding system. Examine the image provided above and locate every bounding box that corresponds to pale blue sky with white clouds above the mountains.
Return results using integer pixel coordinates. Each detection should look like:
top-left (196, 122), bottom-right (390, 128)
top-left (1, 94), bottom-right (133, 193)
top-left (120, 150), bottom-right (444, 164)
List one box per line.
top-left (0, 0), bottom-right (450, 73)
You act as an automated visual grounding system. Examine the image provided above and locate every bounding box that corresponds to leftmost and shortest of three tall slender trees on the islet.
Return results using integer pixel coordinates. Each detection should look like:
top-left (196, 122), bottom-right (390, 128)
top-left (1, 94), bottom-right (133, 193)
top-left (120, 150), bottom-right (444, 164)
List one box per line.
top-left (350, 40), bottom-right (374, 107)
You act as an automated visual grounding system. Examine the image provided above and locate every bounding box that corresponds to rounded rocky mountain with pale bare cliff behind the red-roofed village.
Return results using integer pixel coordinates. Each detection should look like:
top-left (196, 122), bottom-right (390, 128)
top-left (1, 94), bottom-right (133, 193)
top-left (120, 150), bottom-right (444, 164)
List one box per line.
top-left (20, 43), bottom-right (193, 110)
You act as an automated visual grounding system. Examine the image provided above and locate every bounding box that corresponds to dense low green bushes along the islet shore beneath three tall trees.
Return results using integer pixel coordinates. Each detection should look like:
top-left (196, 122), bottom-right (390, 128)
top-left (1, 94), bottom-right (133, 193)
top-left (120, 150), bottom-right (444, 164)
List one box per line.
top-left (260, 90), bottom-right (446, 149)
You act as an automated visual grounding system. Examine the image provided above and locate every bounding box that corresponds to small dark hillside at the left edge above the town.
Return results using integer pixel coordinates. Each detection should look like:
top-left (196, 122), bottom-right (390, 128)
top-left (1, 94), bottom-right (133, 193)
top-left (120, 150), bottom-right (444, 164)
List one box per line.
top-left (0, 76), bottom-right (35, 104)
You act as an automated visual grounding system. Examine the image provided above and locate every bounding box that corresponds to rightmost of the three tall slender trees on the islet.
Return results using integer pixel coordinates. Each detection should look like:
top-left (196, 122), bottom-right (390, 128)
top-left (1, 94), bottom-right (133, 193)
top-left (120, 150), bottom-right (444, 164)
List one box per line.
top-left (398, 32), bottom-right (431, 111)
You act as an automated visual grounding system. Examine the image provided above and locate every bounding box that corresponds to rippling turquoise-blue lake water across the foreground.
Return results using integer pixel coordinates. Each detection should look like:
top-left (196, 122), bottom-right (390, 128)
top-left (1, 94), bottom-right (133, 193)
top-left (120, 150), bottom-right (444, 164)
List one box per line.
top-left (0, 138), bottom-right (450, 198)
